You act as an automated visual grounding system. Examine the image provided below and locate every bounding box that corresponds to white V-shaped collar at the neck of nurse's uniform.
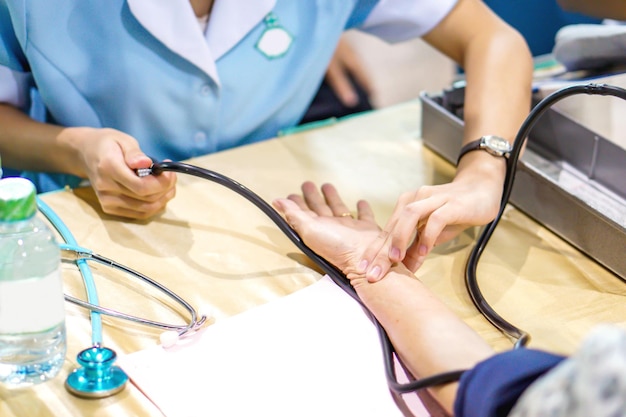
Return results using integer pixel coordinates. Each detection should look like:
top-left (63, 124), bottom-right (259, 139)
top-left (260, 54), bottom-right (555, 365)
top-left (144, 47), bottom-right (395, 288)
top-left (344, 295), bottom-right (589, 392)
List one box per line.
top-left (128, 0), bottom-right (276, 85)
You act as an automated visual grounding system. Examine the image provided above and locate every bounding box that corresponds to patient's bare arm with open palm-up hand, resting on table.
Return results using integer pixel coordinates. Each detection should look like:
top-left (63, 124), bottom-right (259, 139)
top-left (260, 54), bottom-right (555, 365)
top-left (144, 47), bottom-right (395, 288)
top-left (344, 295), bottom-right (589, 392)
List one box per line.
top-left (274, 183), bottom-right (493, 413)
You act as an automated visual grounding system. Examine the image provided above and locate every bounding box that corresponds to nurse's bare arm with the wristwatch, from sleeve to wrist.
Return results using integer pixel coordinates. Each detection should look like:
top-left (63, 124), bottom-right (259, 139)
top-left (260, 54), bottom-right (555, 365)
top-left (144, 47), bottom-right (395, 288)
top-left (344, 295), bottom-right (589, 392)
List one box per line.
top-left (424, 0), bottom-right (533, 188)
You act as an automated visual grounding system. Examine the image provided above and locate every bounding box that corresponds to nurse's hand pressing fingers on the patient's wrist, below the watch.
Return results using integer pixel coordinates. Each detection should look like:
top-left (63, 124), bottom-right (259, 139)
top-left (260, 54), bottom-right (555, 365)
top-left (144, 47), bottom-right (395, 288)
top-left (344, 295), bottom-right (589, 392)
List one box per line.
top-left (359, 152), bottom-right (505, 282)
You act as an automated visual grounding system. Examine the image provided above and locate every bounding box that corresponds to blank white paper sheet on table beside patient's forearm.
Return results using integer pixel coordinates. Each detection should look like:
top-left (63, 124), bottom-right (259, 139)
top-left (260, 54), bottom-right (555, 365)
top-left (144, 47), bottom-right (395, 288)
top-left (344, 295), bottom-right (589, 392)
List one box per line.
top-left (119, 277), bottom-right (429, 417)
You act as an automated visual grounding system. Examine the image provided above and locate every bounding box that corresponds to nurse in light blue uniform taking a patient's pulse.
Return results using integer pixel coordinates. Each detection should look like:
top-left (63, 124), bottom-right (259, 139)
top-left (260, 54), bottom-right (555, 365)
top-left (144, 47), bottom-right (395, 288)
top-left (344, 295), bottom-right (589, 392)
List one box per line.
top-left (0, 0), bottom-right (532, 270)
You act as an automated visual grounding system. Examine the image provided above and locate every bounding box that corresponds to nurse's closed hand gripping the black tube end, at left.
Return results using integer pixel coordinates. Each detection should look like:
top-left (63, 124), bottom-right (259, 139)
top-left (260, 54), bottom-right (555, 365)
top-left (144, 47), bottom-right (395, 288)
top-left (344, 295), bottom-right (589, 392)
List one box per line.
top-left (64, 127), bottom-right (176, 219)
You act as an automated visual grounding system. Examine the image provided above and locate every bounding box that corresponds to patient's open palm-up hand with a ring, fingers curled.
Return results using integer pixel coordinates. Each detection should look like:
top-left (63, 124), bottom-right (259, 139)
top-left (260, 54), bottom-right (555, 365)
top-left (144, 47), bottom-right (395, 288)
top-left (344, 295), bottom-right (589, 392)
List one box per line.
top-left (273, 182), bottom-right (380, 278)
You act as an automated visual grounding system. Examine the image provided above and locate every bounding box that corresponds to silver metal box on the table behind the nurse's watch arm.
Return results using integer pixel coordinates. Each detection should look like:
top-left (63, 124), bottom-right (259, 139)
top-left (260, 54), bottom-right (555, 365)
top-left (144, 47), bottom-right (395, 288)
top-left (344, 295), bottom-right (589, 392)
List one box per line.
top-left (420, 87), bottom-right (626, 279)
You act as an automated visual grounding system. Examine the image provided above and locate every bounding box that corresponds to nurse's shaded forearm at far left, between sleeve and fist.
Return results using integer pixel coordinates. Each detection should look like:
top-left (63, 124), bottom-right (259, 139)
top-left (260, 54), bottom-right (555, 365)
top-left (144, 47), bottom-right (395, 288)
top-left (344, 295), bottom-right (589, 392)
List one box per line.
top-left (0, 104), bottom-right (84, 176)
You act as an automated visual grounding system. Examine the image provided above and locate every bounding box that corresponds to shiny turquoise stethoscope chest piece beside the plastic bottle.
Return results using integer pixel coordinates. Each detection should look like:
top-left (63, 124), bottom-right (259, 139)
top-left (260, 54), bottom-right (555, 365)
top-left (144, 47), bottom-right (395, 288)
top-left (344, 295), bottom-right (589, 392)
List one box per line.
top-left (65, 346), bottom-right (128, 398)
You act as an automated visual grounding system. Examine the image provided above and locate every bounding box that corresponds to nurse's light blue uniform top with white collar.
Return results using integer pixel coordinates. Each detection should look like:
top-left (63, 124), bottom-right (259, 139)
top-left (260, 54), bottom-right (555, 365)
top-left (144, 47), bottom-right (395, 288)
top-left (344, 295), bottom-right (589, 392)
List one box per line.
top-left (0, 0), bottom-right (453, 191)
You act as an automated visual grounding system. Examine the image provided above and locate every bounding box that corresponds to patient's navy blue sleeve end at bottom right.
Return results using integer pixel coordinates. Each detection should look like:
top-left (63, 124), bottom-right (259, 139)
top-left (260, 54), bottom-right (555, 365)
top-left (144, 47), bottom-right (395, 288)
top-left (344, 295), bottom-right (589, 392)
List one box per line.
top-left (454, 349), bottom-right (564, 417)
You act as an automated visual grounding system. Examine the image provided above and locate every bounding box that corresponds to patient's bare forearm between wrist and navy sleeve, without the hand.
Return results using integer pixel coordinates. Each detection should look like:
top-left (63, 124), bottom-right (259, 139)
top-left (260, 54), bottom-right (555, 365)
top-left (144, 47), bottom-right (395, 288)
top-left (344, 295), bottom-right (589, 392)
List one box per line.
top-left (351, 265), bottom-right (493, 412)
